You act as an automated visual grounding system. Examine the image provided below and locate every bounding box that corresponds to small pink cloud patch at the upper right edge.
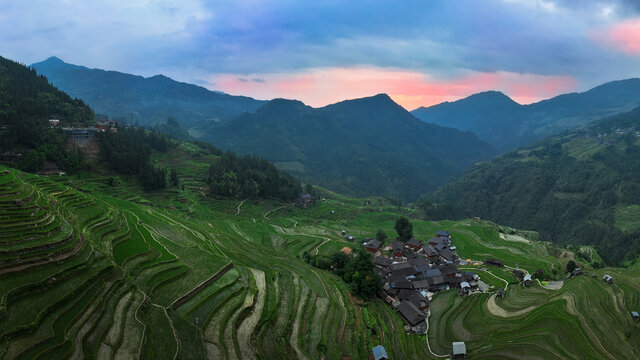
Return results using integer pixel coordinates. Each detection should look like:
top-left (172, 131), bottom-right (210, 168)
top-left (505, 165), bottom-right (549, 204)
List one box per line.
top-left (592, 18), bottom-right (640, 56)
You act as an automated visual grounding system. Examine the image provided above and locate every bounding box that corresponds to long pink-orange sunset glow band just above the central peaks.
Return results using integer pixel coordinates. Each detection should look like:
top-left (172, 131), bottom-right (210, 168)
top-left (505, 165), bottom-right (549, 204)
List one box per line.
top-left (210, 67), bottom-right (576, 110)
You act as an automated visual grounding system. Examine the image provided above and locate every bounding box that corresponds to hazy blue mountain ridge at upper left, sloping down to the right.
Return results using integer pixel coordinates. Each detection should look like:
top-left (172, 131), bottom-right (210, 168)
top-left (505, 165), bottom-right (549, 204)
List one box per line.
top-left (31, 57), bottom-right (265, 128)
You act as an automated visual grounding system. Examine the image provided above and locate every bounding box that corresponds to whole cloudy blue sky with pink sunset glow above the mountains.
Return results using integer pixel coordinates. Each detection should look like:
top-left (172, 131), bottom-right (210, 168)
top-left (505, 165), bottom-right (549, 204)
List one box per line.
top-left (0, 0), bottom-right (640, 110)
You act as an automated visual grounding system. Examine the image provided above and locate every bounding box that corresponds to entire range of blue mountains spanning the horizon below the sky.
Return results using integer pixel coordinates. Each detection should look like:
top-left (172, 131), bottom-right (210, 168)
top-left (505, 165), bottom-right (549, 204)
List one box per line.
top-left (32, 58), bottom-right (640, 205)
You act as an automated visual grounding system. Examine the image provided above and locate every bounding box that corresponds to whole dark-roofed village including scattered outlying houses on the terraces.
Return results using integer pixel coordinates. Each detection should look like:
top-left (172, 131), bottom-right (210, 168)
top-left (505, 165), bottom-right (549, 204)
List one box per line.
top-left (358, 230), bottom-right (640, 360)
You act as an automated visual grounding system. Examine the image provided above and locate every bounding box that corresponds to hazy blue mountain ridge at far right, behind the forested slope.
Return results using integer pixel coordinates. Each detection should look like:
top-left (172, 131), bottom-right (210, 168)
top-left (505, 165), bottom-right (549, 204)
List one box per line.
top-left (411, 78), bottom-right (640, 152)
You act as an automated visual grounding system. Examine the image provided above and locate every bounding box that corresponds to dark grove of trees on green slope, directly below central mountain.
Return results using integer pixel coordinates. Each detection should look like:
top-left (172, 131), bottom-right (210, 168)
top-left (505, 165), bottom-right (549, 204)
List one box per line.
top-left (207, 152), bottom-right (302, 201)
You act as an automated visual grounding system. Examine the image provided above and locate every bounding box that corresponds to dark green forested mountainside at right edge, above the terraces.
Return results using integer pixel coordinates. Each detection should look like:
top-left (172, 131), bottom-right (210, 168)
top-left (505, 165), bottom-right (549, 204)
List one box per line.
top-left (419, 109), bottom-right (640, 265)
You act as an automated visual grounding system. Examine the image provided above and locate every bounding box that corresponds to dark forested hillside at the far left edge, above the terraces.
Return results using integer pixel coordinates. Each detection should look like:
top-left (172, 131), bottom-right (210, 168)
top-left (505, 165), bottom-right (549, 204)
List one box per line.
top-left (0, 57), bottom-right (94, 172)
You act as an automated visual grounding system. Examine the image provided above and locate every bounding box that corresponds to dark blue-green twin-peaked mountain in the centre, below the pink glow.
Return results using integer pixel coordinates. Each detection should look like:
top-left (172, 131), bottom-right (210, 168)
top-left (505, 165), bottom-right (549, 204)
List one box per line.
top-left (204, 94), bottom-right (495, 201)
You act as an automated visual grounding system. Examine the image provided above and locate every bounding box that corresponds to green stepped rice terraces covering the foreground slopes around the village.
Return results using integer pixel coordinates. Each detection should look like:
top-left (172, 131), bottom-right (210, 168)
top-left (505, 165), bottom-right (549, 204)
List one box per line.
top-left (0, 164), bottom-right (640, 360)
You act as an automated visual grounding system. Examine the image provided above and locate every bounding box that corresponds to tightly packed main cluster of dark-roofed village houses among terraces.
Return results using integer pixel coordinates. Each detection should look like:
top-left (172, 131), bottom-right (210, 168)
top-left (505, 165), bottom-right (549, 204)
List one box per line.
top-left (362, 231), bottom-right (479, 333)
